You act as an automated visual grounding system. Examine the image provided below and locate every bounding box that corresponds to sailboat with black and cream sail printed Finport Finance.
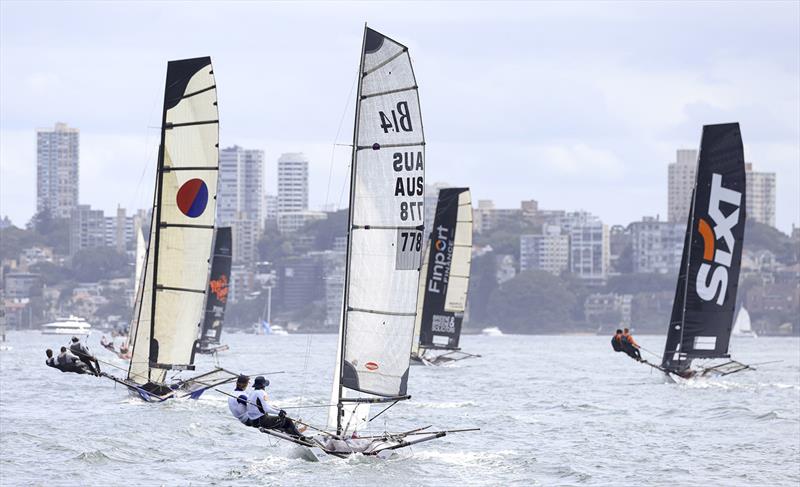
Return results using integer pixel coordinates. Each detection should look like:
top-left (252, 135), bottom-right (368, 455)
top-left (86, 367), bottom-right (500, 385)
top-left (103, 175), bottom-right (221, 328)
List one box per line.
top-left (411, 188), bottom-right (480, 365)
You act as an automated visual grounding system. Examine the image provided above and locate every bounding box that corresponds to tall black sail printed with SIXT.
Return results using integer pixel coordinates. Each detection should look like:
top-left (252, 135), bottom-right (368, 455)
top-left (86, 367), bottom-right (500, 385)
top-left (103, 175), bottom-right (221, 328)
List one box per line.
top-left (662, 123), bottom-right (746, 371)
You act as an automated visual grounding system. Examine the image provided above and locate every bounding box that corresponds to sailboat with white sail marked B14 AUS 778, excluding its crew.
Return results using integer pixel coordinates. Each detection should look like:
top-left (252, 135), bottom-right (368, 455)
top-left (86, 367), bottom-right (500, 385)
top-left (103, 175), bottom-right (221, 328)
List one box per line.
top-left (261, 26), bottom-right (478, 457)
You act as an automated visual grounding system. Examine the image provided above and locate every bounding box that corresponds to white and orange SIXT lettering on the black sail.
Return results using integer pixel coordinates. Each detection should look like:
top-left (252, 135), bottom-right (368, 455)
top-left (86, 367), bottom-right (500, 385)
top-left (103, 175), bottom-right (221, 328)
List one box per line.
top-left (695, 173), bottom-right (742, 306)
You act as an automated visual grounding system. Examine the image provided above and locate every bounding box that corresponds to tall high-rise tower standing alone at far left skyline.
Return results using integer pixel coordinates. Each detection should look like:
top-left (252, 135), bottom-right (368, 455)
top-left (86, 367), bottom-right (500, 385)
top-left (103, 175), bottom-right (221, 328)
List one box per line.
top-left (36, 123), bottom-right (80, 218)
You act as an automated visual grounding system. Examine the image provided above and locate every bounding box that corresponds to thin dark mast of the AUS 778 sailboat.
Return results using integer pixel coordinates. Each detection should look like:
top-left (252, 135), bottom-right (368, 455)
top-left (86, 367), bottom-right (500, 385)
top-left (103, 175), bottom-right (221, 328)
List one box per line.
top-left (336, 22), bottom-right (367, 435)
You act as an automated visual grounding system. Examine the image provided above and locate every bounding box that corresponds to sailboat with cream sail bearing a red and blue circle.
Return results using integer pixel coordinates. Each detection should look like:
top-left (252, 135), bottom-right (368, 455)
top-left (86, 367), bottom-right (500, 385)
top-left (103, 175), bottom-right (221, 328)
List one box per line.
top-left (104, 57), bottom-right (236, 402)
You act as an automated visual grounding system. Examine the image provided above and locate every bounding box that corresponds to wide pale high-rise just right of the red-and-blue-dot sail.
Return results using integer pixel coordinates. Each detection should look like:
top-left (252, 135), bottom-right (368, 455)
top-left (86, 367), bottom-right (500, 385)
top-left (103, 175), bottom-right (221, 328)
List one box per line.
top-left (217, 146), bottom-right (264, 263)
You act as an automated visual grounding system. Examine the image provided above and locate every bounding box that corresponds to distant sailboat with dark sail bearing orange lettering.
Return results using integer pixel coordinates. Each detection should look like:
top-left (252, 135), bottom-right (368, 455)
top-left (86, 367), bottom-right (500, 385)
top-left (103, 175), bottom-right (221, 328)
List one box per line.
top-left (197, 227), bottom-right (233, 353)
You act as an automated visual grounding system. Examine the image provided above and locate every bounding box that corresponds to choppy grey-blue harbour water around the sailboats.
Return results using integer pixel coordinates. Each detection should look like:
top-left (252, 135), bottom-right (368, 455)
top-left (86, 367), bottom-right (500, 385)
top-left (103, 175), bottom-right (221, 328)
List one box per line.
top-left (0, 332), bottom-right (800, 486)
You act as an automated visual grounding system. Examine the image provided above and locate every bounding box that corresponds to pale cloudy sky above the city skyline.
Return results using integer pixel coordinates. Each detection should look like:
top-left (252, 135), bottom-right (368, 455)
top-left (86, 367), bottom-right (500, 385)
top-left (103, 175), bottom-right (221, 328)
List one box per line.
top-left (0, 0), bottom-right (800, 232)
